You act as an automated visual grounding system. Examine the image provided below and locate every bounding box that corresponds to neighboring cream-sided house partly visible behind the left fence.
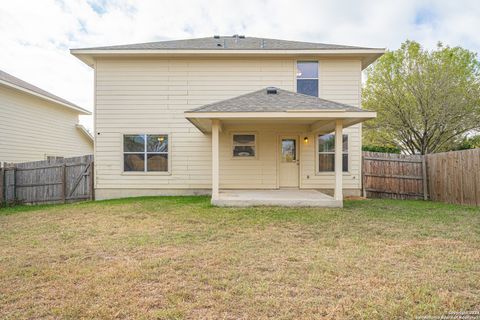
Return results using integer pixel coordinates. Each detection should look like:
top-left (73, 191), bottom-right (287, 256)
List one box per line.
top-left (0, 70), bottom-right (93, 163)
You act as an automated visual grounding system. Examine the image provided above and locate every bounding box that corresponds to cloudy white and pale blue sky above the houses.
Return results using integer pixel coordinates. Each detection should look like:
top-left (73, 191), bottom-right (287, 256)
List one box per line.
top-left (0, 0), bottom-right (480, 127)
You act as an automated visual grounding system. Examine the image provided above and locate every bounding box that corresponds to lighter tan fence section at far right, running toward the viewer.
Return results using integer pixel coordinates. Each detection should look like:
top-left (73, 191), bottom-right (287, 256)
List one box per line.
top-left (426, 149), bottom-right (480, 206)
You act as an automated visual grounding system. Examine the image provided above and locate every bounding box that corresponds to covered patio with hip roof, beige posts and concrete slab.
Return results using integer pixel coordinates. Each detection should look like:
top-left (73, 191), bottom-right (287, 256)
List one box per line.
top-left (185, 87), bottom-right (376, 207)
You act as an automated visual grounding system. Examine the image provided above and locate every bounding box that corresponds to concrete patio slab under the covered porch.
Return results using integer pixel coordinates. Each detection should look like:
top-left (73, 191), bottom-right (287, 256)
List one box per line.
top-left (212, 189), bottom-right (343, 208)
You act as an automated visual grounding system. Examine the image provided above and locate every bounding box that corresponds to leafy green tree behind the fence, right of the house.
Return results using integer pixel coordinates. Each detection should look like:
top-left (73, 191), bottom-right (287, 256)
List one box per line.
top-left (363, 41), bottom-right (480, 154)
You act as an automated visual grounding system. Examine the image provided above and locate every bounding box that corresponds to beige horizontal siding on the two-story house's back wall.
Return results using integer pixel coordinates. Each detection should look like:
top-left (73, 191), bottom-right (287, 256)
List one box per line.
top-left (95, 58), bottom-right (360, 194)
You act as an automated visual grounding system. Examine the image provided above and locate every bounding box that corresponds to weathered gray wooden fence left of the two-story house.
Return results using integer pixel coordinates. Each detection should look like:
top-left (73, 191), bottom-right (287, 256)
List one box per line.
top-left (0, 155), bottom-right (94, 204)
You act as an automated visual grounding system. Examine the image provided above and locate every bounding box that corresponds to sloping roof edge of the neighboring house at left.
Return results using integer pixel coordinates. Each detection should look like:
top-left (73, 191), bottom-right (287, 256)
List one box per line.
top-left (0, 70), bottom-right (91, 115)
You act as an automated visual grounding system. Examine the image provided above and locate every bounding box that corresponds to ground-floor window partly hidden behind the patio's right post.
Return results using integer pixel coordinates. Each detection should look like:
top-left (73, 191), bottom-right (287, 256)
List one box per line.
top-left (318, 134), bottom-right (348, 172)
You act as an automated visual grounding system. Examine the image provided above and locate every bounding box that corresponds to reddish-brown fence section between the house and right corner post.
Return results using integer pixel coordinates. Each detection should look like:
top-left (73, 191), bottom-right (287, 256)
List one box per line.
top-left (362, 152), bottom-right (428, 199)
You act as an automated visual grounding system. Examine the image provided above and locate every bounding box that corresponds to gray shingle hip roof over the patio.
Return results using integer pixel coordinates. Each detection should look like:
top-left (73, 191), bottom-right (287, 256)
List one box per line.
top-left (188, 88), bottom-right (366, 112)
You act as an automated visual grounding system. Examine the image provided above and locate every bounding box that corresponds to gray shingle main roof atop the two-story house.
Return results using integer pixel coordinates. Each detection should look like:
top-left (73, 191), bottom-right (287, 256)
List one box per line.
top-left (78, 36), bottom-right (377, 50)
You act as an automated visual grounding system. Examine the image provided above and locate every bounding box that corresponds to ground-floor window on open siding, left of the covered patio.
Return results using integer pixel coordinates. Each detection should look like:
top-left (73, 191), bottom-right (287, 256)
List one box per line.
top-left (123, 134), bottom-right (168, 172)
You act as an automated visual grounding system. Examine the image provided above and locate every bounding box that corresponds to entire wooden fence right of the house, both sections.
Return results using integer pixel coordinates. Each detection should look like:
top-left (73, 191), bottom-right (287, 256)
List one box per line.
top-left (362, 149), bottom-right (480, 206)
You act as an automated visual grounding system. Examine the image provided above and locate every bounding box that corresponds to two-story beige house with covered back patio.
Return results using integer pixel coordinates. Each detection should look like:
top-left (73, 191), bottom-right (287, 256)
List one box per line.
top-left (71, 35), bottom-right (384, 206)
